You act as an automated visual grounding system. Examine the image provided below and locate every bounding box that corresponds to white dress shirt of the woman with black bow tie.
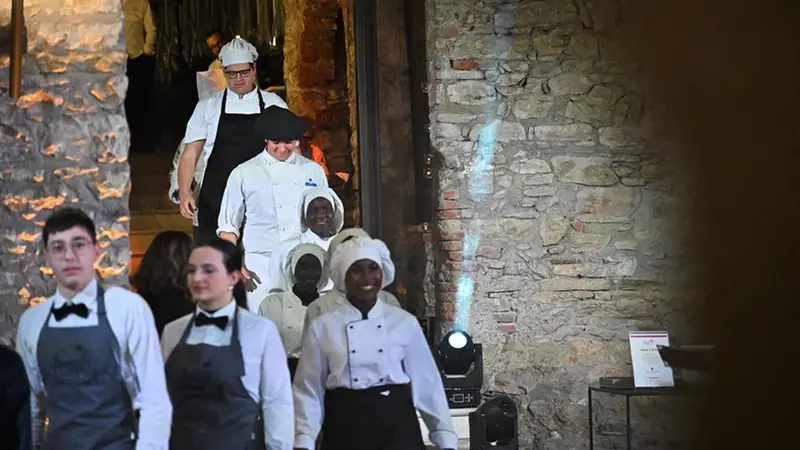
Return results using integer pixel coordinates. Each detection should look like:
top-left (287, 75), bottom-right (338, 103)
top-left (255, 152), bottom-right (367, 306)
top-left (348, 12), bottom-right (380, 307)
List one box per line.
top-left (161, 302), bottom-right (294, 450)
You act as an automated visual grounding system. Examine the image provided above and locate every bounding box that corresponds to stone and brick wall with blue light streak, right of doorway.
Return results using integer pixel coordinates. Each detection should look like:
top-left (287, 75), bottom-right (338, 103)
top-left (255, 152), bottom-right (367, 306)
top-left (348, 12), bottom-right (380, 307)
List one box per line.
top-left (428, 0), bottom-right (689, 449)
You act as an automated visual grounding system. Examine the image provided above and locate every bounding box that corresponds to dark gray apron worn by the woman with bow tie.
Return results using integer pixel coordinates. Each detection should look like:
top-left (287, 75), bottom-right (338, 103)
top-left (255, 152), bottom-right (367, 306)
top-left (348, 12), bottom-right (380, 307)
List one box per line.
top-left (166, 307), bottom-right (266, 450)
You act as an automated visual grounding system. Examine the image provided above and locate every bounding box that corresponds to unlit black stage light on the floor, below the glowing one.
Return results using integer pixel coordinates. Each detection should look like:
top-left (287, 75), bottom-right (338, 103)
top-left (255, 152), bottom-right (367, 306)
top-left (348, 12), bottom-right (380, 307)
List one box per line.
top-left (469, 395), bottom-right (519, 450)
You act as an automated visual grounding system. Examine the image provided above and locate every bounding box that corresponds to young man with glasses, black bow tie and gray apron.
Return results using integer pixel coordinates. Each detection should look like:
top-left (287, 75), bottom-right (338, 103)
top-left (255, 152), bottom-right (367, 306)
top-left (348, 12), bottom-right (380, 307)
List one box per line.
top-left (17, 208), bottom-right (172, 450)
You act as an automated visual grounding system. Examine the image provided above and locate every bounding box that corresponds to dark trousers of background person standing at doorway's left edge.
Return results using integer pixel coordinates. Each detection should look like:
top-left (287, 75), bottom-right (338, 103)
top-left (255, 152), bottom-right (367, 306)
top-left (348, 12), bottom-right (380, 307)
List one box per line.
top-left (125, 54), bottom-right (156, 153)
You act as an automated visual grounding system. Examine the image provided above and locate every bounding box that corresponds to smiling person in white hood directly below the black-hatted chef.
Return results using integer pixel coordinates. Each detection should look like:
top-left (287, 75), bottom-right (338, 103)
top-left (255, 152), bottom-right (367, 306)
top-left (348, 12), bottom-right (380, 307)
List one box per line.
top-left (262, 187), bottom-right (344, 294)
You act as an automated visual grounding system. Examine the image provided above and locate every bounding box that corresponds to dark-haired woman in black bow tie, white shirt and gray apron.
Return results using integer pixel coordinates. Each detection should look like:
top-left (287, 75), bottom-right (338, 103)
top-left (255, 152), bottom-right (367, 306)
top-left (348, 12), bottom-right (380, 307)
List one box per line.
top-left (161, 238), bottom-right (294, 450)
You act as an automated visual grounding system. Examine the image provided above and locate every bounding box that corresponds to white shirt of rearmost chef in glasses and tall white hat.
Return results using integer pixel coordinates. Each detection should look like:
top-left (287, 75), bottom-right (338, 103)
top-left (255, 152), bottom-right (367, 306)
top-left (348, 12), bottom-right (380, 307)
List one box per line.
top-left (181, 89), bottom-right (289, 197)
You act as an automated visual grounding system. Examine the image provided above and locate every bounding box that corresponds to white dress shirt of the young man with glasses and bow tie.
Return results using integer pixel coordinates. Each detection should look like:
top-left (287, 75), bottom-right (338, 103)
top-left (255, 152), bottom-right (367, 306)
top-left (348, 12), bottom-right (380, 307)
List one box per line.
top-left (17, 280), bottom-right (172, 450)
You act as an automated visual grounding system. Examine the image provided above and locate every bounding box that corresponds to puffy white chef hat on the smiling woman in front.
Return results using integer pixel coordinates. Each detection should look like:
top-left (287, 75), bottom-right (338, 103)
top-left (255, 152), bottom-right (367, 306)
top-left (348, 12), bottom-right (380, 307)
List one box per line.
top-left (330, 238), bottom-right (394, 293)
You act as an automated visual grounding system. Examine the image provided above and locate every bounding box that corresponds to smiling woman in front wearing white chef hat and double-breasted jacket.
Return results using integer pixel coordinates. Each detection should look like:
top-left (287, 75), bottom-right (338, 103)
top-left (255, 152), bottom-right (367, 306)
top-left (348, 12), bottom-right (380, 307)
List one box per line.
top-left (293, 238), bottom-right (458, 450)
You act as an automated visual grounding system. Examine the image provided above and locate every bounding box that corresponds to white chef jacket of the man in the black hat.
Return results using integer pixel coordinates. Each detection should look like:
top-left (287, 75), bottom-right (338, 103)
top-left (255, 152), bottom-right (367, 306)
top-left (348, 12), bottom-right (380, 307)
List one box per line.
top-left (217, 151), bottom-right (328, 255)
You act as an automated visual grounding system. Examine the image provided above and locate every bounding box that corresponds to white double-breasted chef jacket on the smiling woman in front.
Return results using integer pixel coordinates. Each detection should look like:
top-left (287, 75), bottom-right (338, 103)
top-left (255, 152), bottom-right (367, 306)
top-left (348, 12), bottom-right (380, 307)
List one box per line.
top-left (294, 300), bottom-right (458, 449)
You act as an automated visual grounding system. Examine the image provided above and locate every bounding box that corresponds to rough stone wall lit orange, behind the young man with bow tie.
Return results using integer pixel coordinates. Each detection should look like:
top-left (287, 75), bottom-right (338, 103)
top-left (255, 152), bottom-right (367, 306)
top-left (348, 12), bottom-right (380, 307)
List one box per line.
top-left (0, 0), bottom-right (130, 342)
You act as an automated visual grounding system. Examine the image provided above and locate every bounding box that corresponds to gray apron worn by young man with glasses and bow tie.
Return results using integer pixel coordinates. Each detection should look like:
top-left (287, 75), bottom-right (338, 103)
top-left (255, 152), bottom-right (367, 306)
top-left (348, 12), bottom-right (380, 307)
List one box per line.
top-left (37, 284), bottom-right (136, 450)
